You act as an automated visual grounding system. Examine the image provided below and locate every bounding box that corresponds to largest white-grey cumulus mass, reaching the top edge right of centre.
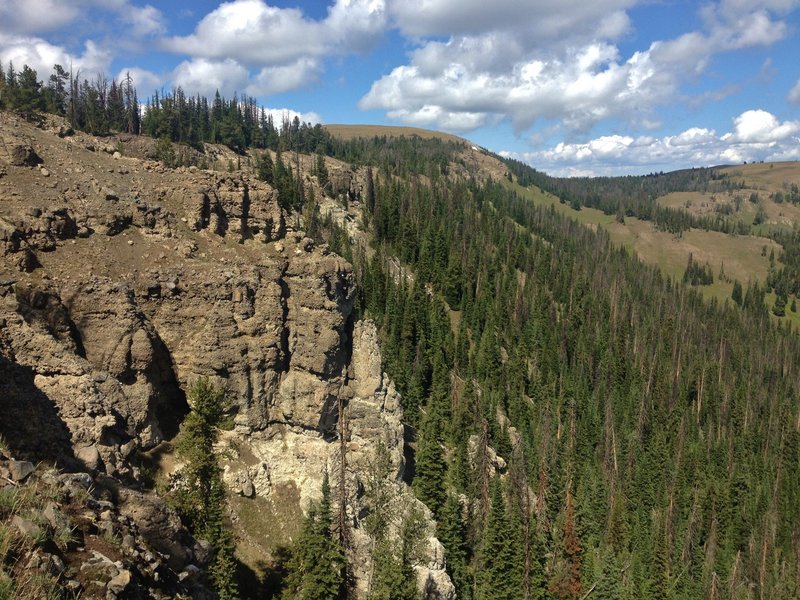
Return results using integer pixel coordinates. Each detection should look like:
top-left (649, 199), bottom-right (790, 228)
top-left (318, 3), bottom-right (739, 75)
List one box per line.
top-left (359, 0), bottom-right (797, 133)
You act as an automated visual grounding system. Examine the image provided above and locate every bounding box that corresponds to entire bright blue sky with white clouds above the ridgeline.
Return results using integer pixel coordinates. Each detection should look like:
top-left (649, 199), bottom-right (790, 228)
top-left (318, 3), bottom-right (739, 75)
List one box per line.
top-left (0, 0), bottom-right (800, 175)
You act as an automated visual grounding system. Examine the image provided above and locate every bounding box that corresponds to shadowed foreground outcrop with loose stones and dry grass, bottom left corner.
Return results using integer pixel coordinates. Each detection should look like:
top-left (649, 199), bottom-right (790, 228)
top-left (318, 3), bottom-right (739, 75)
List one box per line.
top-left (0, 450), bottom-right (216, 600)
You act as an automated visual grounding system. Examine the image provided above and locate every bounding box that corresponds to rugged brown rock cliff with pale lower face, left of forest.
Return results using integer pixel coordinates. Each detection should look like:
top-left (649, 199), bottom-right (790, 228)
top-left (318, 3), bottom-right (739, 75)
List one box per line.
top-left (0, 114), bottom-right (452, 597)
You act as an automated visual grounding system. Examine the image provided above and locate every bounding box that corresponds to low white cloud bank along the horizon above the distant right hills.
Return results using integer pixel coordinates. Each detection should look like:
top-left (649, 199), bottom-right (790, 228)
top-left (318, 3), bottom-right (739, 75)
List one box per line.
top-left (501, 110), bottom-right (800, 176)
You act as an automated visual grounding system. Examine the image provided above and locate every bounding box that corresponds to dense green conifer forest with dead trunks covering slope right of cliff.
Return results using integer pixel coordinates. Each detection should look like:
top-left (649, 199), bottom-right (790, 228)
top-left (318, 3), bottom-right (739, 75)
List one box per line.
top-left (356, 162), bottom-right (800, 598)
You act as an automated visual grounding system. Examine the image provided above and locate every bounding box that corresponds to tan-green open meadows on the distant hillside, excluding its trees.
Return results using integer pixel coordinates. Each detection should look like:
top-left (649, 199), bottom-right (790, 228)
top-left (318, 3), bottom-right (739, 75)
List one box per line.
top-left (505, 162), bottom-right (800, 326)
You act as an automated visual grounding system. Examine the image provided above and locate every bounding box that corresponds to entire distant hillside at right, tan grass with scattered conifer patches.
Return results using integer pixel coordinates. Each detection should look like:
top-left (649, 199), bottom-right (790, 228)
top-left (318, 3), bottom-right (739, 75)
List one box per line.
top-left (506, 155), bottom-right (800, 327)
